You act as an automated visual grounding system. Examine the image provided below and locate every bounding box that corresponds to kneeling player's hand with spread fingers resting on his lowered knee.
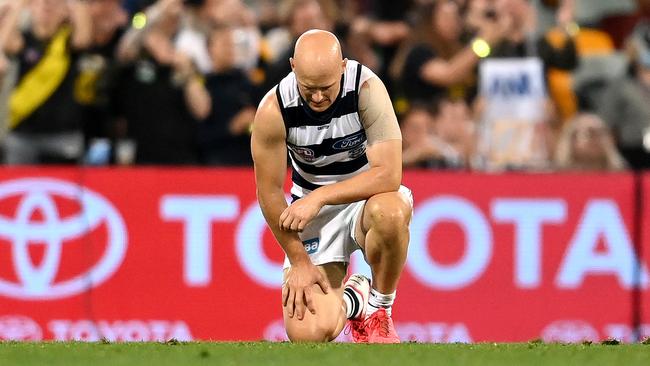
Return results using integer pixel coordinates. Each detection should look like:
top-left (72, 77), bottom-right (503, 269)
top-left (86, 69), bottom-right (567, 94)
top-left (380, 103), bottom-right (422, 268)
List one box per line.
top-left (282, 262), bottom-right (329, 320)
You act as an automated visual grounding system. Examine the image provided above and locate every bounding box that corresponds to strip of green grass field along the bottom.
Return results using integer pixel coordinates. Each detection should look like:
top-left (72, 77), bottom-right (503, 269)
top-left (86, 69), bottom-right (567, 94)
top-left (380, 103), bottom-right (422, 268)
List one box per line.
top-left (0, 342), bottom-right (650, 366)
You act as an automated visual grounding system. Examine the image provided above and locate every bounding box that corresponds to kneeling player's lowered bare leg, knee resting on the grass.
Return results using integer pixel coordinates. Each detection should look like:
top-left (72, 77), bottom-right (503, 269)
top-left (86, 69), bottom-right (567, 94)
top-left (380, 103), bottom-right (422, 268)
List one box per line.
top-left (282, 263), bottom-right (347, 342)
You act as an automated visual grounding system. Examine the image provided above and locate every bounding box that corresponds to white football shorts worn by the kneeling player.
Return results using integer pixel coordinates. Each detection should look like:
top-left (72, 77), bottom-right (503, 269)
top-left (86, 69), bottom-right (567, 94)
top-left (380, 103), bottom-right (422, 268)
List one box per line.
top-left (283, 186), bottom-right (413, 269)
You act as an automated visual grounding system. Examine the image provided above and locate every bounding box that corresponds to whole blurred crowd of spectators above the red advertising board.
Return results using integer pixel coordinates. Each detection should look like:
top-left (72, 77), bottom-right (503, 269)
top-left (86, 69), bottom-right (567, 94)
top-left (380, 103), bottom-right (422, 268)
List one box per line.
top-left (0, 0), bottom-right (650, 171)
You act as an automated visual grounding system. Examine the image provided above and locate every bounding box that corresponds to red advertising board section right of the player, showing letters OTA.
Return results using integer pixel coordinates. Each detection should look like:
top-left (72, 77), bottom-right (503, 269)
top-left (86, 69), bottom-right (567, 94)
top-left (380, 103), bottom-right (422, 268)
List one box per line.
top-left (399, 174), bottom-right (647, 341)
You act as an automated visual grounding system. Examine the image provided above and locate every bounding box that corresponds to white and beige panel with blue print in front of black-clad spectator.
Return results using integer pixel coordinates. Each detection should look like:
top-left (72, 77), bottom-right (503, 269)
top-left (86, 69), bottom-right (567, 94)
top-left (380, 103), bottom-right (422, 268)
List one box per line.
top-left (475, 58), bottom-right (556, 171)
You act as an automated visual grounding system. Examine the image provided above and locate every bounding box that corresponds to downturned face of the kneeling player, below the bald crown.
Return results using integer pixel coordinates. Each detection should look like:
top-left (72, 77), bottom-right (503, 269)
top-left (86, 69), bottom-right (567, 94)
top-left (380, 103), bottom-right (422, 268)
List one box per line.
top-left (291, 59), bottom-right (345, 112)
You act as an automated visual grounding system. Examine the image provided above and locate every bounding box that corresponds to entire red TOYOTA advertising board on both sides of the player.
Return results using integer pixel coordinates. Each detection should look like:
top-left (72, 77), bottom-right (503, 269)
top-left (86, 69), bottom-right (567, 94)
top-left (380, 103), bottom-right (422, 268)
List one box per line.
top-left (0, 168), bottom-right (650, 342)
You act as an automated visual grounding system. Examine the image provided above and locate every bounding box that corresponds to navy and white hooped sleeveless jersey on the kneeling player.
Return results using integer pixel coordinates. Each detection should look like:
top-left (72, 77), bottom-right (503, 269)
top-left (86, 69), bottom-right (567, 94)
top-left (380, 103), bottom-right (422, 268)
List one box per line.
top-left (276, 60), bottom-right (375, 197)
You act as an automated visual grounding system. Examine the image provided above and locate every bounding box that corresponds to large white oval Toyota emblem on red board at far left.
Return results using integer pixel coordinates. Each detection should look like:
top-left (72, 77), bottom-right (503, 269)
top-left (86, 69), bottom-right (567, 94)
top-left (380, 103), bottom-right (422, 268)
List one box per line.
top-left (0, 178), bottom-right (127, 300)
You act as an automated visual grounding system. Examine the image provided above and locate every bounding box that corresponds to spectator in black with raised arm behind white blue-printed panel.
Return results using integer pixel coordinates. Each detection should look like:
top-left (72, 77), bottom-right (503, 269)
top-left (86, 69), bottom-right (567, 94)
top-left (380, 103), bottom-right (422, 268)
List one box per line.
top-left (476, 0), bottom-right (577, 170)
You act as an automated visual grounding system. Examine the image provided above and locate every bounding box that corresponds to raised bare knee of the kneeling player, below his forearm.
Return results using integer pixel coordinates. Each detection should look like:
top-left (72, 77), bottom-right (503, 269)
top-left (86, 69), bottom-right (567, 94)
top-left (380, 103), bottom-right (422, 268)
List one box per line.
top-left (364, 192), bottom-right (412, 236)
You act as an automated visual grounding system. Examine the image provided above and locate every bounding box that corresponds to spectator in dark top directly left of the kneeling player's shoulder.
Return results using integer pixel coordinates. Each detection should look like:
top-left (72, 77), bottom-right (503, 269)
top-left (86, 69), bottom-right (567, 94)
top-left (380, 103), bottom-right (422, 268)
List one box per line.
top-left (199, 27), bottom-right (255, 166)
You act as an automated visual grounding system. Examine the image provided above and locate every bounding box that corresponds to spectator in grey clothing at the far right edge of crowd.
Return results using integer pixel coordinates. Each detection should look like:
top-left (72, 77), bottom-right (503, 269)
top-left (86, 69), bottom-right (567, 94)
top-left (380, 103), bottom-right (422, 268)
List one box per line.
top-left (595, 23), bottom-right (650, 169)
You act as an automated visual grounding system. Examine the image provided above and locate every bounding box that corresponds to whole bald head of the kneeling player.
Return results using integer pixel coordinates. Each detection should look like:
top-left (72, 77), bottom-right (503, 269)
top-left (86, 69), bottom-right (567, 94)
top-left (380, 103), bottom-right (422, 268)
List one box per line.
top-left (290, 30), bottom-right (347, 111)
